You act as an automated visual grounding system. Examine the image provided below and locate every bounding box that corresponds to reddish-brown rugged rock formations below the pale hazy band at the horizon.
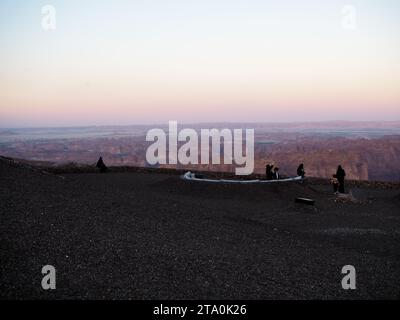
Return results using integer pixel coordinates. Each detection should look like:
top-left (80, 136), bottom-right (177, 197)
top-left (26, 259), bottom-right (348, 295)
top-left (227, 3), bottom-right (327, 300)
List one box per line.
top-left (0, 132), bottom-right (400, 181)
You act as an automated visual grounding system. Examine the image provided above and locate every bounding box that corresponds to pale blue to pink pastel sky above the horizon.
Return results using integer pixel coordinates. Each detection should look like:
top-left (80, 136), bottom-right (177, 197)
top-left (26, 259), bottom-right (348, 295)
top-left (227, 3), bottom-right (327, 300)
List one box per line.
top-left (0, 0), bottom-right (400, 127)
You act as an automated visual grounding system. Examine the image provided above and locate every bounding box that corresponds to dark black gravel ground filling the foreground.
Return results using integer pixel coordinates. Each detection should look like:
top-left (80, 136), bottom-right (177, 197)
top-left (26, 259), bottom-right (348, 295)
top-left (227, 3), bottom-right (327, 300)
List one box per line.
top-left (0, 161), bottom-right (400, 299)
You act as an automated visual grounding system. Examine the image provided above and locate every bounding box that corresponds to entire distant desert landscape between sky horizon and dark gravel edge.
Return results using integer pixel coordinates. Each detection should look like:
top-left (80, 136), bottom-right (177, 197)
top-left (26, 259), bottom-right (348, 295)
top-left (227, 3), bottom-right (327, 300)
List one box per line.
top-left (0, 121), bottom-right (400, 181)
